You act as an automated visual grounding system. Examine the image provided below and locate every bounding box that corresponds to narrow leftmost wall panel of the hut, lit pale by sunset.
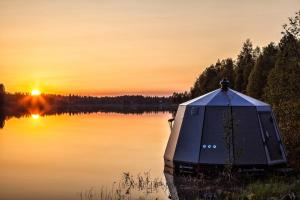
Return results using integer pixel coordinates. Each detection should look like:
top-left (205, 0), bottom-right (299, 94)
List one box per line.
top-left (164, 105), bottom-right (186, 166)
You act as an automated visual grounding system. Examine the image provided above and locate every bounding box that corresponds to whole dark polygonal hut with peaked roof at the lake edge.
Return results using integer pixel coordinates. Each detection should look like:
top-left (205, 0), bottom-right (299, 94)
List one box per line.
top-left (164, 79), bottom-right (286, 169)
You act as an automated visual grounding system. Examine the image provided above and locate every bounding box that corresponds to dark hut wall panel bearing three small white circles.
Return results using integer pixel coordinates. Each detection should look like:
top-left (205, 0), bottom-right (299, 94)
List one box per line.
top-left (199, 106), bottom-right (232, 164)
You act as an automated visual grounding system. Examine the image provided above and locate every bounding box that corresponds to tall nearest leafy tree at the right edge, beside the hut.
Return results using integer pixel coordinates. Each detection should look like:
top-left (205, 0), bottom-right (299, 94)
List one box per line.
top-left (265, 34), bottom-right (300, 150)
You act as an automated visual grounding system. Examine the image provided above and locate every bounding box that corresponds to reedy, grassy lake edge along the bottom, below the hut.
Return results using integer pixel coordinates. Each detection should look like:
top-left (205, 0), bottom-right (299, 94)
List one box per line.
top-left (78, 172), bottom-right (300, 200)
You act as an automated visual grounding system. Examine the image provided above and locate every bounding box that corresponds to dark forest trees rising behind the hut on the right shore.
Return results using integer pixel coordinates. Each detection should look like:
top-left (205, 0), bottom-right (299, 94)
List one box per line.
top-left (173, 11), bottom-right (300, 166)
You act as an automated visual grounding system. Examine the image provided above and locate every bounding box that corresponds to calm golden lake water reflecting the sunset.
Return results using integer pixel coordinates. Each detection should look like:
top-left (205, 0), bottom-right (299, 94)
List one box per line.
top-left (0, 113), bottom-right (171, 200)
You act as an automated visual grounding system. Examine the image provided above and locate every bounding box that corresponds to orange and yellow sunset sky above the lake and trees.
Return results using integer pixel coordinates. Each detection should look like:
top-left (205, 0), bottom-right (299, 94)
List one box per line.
top-left (0, 0), bottom-right (300, 95)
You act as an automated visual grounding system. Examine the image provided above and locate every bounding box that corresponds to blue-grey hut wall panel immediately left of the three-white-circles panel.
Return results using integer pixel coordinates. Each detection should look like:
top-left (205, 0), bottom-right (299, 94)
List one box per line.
top-left (174, 106), bottom-right (205, 164)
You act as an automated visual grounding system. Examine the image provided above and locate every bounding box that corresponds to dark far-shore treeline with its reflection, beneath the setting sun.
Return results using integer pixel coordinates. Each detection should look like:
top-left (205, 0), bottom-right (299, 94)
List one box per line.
top-left (0, 89), bottom-right (176, 117)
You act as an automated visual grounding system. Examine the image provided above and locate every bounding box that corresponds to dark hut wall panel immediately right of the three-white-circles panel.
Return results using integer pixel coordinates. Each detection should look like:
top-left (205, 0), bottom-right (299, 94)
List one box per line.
top-left (232, 106), bottom-right (267, 165)
